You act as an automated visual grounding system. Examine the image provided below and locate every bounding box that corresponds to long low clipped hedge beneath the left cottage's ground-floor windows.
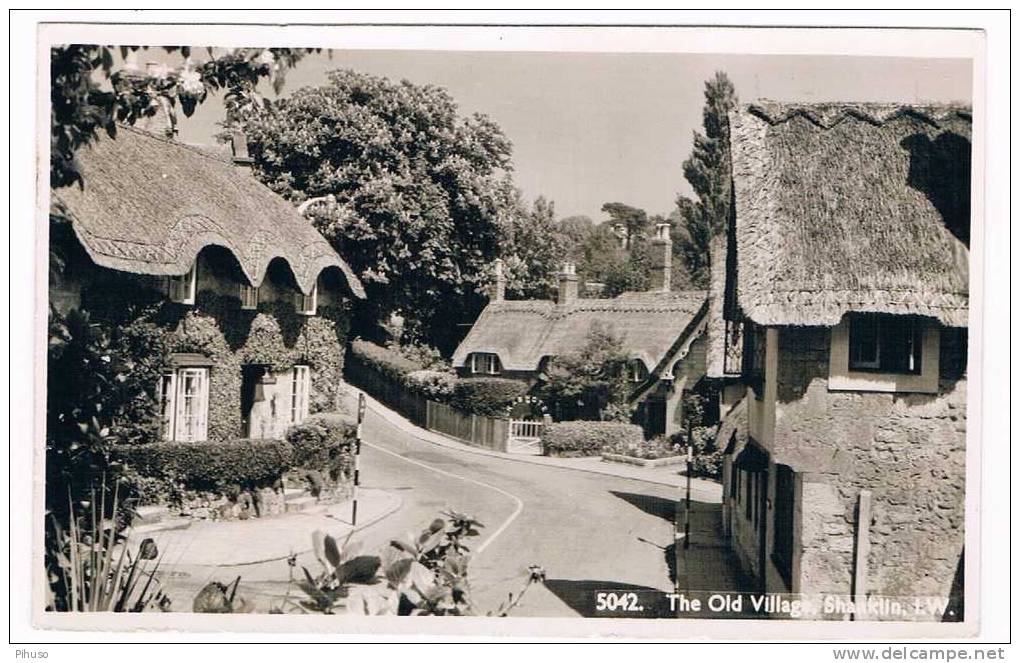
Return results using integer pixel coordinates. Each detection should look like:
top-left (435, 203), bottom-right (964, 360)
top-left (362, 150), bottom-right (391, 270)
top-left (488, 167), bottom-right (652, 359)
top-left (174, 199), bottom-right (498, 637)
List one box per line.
top-left (114, 440), bottom-right (294, 492)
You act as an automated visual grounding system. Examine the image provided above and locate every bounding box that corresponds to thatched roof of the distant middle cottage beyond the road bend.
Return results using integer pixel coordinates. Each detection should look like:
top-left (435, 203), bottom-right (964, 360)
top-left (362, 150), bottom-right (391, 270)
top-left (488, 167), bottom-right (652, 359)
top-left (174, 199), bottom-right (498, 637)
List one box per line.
top-left (453, 291), bottom-right (707, 371)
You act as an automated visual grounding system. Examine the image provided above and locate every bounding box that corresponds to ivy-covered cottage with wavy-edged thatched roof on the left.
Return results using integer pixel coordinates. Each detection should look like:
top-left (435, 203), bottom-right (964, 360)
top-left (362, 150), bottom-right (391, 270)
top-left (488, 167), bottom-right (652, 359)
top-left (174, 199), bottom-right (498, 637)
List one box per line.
top-left (50, 126), bottom-right (364, 442)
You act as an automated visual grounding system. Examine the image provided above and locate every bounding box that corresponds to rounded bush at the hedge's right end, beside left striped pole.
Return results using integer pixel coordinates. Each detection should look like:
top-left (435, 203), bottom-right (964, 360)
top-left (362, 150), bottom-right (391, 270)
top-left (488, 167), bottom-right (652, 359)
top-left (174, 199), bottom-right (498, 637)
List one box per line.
top-left (287, 414), bottom-right (357, 481)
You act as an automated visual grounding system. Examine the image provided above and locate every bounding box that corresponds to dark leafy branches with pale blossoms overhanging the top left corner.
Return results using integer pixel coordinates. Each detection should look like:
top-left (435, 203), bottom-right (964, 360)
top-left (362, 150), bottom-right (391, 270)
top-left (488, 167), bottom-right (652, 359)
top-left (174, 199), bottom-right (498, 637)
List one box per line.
top-left (50, 44), bottom-right (318, 188)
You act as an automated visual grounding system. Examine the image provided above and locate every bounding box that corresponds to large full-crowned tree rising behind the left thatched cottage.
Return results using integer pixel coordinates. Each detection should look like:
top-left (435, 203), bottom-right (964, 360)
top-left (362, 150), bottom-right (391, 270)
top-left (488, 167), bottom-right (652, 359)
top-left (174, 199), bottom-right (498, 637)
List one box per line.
top-left (227, 70), bottom-right (517, 352)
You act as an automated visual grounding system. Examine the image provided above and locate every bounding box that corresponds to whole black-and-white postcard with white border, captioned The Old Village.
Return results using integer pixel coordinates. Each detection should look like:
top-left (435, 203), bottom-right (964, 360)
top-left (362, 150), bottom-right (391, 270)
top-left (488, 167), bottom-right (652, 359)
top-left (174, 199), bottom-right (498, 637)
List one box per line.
top-left (11, 10), bottom-right (1007, 640)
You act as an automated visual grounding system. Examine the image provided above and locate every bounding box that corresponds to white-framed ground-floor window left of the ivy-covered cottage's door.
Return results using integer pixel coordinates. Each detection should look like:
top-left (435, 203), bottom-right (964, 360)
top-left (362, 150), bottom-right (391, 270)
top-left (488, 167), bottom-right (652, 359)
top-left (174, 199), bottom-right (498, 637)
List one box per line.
top-left (159, 367), bottom-right (209, 442)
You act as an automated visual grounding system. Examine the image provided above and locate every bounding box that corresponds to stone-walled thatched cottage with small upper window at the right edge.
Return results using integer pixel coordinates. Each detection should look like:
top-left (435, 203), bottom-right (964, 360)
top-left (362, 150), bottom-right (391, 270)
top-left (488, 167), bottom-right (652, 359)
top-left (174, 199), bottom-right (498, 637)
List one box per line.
top-left (709, 103), bottom-right (971, 620)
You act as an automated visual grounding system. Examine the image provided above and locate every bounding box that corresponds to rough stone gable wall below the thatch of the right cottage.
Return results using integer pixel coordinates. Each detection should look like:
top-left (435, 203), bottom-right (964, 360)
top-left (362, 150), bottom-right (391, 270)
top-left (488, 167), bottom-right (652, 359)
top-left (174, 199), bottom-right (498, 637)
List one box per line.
top-left (775, 327), bottom-right (966, 616)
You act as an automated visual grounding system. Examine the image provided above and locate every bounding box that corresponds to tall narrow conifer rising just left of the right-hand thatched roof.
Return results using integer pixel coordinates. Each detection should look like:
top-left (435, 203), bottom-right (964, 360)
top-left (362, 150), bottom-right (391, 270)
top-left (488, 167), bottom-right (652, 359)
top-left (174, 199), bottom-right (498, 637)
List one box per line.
top-left (676, 71), bottom-right (737, 286)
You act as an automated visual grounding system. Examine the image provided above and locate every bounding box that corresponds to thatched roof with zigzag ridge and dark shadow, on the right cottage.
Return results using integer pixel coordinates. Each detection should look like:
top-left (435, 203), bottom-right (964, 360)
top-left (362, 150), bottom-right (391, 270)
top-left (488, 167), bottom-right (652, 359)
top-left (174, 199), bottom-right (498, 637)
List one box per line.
top-left (729, 102), bottom-right (971, 326)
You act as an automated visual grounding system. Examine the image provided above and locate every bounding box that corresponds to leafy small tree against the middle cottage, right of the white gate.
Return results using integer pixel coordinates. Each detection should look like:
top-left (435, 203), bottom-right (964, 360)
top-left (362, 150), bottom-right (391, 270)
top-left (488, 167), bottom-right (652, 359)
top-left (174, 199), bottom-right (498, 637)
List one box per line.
top-left (538, 322), bottom-right (630, 421)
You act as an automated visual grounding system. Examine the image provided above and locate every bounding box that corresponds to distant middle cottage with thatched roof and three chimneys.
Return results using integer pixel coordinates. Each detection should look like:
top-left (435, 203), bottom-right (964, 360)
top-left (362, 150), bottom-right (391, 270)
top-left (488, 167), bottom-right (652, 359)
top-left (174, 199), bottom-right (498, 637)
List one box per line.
top-left (453, 223), bottom-right (708, 437)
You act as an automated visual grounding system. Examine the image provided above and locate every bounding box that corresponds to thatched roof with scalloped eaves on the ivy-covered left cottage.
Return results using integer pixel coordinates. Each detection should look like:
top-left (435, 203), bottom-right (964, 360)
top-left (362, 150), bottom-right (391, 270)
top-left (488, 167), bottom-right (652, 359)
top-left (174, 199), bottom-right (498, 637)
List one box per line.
top-left (53, 126), bottom-right (364, 298)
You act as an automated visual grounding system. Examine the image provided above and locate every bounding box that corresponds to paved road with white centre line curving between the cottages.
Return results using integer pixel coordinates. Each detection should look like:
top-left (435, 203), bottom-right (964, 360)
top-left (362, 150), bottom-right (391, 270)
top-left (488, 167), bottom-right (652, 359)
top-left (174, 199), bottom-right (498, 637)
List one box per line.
top-left (350, 399), bottom-right (733, 617)
